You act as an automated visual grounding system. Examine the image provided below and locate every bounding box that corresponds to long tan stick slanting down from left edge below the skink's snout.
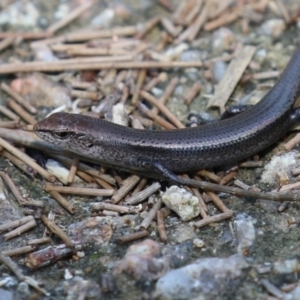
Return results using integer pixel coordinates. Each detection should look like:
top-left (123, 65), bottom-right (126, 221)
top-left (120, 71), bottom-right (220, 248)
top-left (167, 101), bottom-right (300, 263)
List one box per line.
top-left (0, 138), bottom-right (55, 182)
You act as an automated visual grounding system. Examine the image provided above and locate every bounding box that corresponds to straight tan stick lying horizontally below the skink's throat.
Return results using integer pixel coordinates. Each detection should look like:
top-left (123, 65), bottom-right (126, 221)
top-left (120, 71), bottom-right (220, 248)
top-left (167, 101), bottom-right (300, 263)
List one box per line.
top-left (44, 184), bottom-right (114, 196)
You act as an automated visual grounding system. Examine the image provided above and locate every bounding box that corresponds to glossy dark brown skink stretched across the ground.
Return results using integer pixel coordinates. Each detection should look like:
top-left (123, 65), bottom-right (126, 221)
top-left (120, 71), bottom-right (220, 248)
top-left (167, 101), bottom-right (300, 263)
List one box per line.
top-left (34, 48), bottom-right (300, 183)
